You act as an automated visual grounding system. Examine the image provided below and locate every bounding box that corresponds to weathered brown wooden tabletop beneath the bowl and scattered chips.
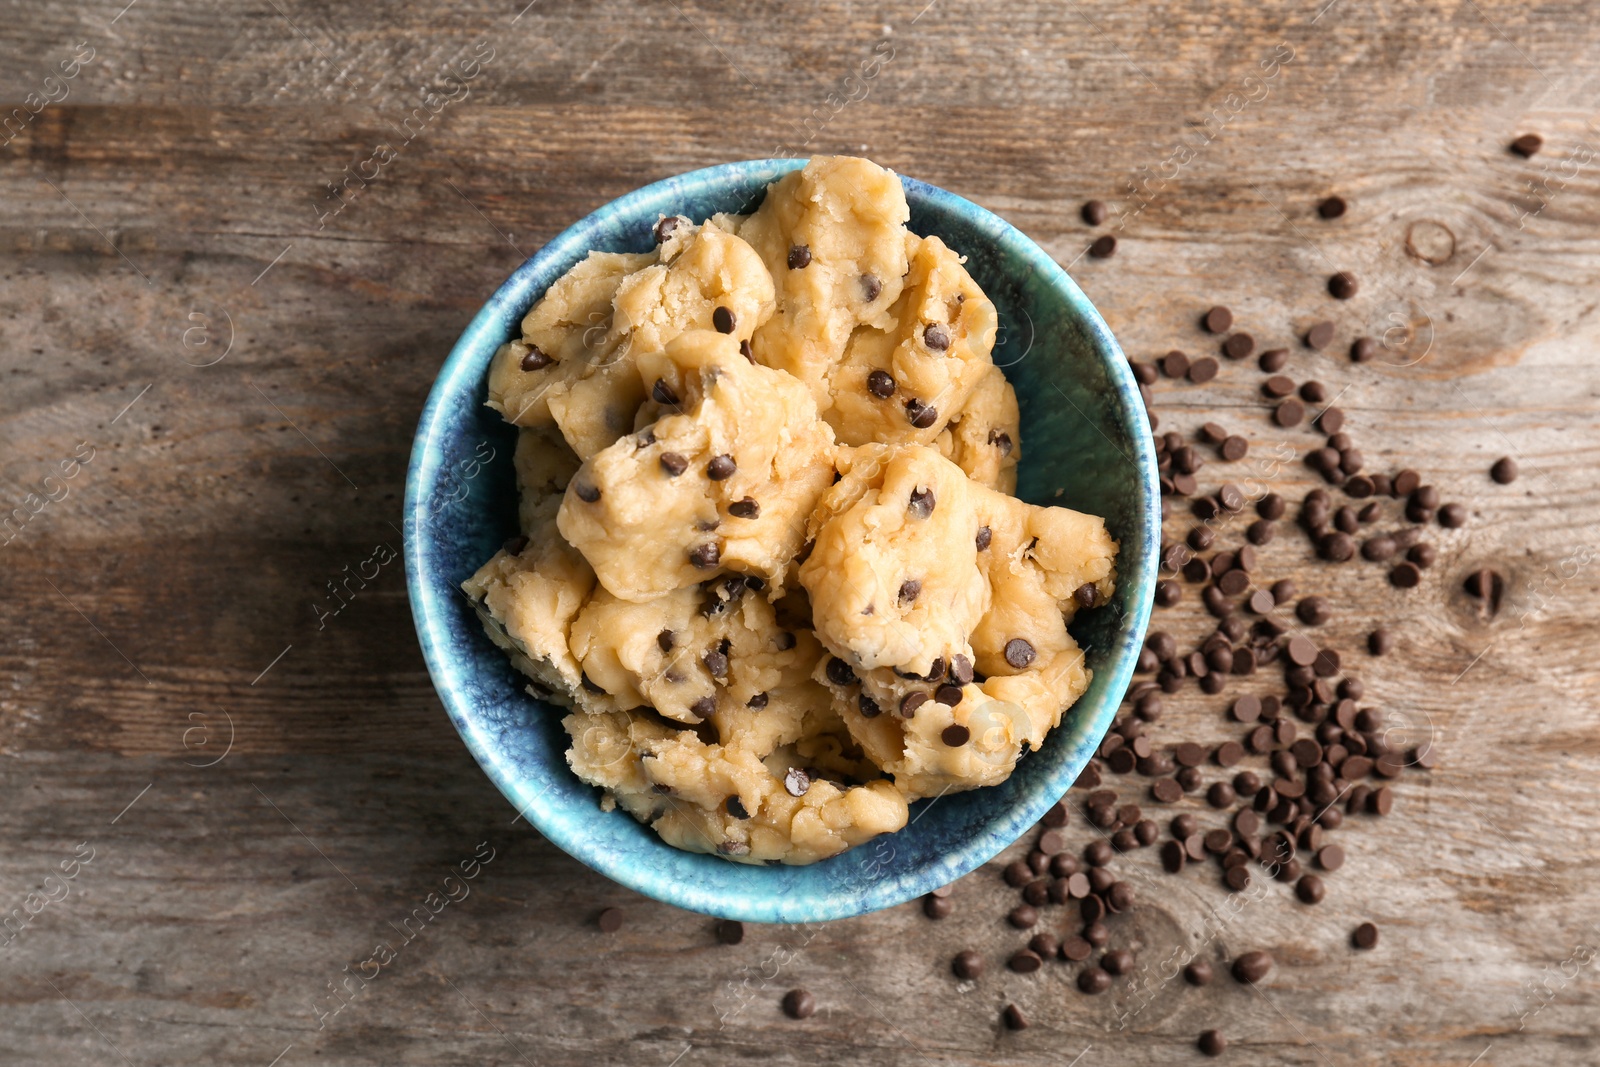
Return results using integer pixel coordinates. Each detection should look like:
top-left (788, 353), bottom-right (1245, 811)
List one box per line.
top-left (0, 0), bottom-right (1600, 1067)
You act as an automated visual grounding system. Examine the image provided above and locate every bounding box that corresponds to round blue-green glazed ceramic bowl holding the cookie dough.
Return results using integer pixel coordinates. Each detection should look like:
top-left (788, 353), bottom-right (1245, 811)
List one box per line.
top-left (405, 160), bottom-right (1160, 923)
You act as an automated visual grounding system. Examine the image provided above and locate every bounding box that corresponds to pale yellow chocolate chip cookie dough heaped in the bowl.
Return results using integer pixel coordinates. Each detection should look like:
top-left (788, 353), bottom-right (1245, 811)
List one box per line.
top-left (462, 158), bottom-right (1117, 864)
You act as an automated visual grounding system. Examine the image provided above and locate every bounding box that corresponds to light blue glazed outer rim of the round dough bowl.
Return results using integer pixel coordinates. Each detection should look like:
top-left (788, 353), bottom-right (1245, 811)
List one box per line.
top-left (402, 158), bottom-right (1160, 921)
